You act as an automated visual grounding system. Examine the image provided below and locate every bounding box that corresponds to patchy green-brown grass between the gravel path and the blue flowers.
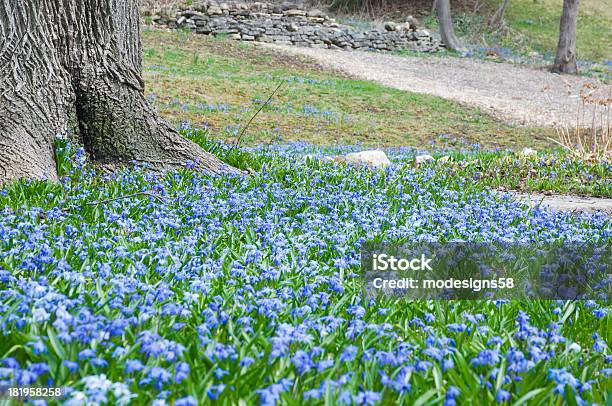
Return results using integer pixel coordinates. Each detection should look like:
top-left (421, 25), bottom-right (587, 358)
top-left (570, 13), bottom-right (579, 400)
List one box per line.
top-left (143, 30), bottom-right (551, 147)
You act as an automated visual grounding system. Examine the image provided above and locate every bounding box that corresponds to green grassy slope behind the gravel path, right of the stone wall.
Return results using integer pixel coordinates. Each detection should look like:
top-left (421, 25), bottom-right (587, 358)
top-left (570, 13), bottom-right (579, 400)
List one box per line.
top-left (420, 0), bottom-right (612, 78)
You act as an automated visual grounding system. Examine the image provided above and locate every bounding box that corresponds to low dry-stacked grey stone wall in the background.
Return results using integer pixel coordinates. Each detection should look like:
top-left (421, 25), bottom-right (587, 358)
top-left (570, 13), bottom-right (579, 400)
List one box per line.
top-left (146, 0), bottom-right (441, 52)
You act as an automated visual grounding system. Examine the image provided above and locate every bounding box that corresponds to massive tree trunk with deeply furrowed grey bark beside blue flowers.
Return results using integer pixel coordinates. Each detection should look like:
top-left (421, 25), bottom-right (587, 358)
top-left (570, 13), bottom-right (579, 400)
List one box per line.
top-left (0, 0), bottom-right (238, 183)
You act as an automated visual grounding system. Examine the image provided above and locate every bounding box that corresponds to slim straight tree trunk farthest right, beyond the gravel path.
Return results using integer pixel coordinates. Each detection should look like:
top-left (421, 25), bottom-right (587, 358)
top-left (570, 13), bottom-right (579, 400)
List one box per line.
top-left (552, 0), bottom-right (579, 73)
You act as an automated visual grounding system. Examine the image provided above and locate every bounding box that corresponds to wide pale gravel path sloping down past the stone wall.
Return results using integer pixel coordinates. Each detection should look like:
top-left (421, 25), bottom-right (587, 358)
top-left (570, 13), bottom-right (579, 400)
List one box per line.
top-left (266, 45), bottom-right (612, 126)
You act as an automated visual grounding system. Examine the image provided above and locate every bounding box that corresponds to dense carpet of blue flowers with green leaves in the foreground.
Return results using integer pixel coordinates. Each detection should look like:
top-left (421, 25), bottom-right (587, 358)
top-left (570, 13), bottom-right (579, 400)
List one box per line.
top-left (0, 138), bottom-right (612, 406)
